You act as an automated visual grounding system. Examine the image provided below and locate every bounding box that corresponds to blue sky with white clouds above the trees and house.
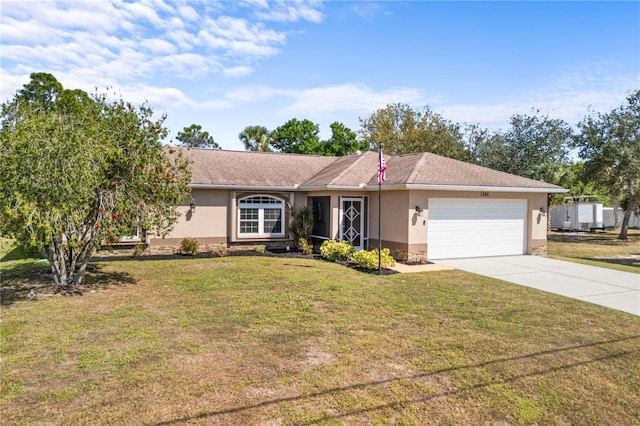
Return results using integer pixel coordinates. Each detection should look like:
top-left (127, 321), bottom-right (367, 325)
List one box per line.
top-left (0, 0), bottom-right (640, 150)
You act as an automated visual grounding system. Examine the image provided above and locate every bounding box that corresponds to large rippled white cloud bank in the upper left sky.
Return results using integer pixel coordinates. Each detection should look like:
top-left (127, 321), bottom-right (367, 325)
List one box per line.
top-left (0, 0), bottom-right (300, 93)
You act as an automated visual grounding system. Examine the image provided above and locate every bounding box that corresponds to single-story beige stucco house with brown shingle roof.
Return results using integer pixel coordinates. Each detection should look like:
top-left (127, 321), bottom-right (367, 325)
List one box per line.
top-left (147, 149), bottom-right (566, 261)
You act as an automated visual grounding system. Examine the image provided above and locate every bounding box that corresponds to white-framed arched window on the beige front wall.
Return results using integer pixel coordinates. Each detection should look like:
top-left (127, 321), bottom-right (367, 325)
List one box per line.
top-left (238, 195), bottom-right (284, 237)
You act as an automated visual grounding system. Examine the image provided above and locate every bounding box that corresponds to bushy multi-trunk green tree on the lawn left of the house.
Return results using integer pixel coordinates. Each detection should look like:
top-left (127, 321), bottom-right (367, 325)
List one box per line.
top-left (0, 73), bottom-right (191, 293)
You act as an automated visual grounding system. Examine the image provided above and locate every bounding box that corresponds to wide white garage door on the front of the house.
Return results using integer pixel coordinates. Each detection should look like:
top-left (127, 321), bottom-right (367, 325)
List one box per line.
top-left (427, 199), bottom-right (527, 260)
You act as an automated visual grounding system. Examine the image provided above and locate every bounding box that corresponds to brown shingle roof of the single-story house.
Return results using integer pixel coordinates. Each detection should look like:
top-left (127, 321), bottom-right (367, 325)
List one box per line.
top-left (178, 149), bottom-right (563, 192)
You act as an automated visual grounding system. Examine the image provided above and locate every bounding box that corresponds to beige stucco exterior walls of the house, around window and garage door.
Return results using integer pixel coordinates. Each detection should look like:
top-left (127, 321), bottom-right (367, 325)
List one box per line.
top-left (150, 189), bottom-right (547, 260)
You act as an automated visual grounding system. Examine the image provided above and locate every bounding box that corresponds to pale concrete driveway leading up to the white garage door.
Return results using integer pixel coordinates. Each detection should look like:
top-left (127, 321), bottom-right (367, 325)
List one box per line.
top-left (436, 256), bottom-right (640, 316)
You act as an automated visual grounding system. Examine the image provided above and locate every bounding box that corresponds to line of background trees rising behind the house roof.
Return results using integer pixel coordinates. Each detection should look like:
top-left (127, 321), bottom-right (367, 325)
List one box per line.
top-left (222, 94), bottom-right (640, 238)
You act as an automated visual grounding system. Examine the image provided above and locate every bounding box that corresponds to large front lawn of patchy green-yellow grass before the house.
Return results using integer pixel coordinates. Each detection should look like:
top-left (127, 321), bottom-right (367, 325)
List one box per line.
top-left (0, 256), bottom-right (640, 425)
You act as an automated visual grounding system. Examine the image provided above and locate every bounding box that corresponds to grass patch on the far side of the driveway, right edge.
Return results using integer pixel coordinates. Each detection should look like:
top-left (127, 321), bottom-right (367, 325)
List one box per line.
top-left (548, 229), bottom-right (640, 274)
